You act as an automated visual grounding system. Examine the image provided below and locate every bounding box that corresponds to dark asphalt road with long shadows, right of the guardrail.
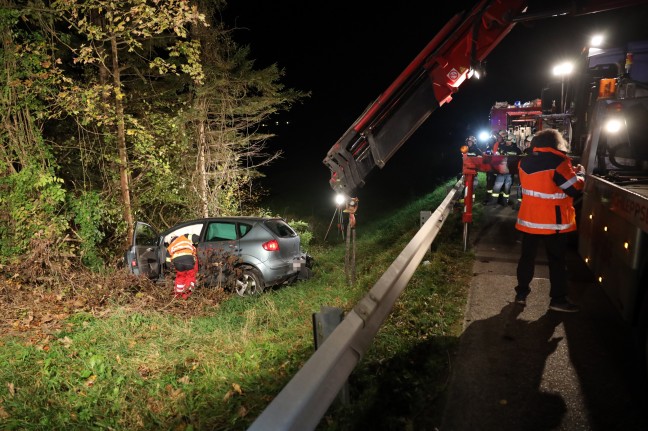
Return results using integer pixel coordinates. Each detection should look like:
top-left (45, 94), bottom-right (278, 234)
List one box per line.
top-left (441, 206), bottom-right (648, 431)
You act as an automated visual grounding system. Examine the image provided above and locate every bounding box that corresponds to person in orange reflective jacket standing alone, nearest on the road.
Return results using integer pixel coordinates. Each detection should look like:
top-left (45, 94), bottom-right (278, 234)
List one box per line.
top-left (515, 129), bottom-right (585, 312)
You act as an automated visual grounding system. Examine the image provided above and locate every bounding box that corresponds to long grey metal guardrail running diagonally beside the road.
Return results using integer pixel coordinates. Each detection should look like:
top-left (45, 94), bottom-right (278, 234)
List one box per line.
top-left (248, 180), bottom-right (463, 431)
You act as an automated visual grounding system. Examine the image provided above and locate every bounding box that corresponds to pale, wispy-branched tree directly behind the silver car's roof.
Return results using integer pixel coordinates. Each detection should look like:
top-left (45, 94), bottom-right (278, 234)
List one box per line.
top-left (185, 9), bottom-right (308, 217)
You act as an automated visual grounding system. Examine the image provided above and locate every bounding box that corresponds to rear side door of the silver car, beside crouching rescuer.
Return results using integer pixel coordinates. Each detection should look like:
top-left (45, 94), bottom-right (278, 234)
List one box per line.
top-left (198, 220), bottom-right (240, 284)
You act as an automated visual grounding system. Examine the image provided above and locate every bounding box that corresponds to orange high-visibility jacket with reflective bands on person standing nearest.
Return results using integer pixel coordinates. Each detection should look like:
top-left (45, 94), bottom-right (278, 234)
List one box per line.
top-left (515, 147), bottom-right (585, 235)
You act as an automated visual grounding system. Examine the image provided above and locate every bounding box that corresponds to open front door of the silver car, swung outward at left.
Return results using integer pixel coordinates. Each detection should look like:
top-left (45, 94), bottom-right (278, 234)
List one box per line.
top-left (126, 221), bottom-right (162, 278)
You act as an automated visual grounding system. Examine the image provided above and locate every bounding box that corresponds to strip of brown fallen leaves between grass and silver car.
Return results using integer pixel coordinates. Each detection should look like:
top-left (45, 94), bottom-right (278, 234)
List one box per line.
top-left (0, 266), bottom-right (228, 336)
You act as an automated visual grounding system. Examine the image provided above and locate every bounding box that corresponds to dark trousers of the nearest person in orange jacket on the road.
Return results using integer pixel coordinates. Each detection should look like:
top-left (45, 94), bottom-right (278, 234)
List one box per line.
top-left (516, 232), bottom-right (568, 298)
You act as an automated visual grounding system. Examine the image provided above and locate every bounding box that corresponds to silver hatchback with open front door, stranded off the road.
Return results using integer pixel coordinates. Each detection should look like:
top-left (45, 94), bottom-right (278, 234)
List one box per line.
top-left (125, 217), bottom-right (312, 296)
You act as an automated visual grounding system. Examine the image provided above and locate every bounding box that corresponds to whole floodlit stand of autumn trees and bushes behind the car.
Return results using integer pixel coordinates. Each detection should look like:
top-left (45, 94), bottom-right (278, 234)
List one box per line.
top-left (0, 0), bottom-right (303, 269)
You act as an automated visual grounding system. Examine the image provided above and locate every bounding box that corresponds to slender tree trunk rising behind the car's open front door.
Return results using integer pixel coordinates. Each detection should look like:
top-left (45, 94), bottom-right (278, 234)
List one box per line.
top-left (110, 35), bottom-right (135, 243)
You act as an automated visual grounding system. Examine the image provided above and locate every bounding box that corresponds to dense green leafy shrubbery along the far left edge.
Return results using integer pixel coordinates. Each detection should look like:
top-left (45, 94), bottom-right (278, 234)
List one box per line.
top-left (0, 5), bottom-right (67, 260)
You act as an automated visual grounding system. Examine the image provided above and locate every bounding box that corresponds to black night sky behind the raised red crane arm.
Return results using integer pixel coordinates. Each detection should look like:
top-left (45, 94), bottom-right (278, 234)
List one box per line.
top-left (224, 0), bottom-right (648, 215)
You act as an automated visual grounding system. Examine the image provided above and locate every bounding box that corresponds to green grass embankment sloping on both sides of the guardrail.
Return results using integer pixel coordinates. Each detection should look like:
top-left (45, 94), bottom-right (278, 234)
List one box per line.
top-left (0, 177), bottom-right (472, 430)
